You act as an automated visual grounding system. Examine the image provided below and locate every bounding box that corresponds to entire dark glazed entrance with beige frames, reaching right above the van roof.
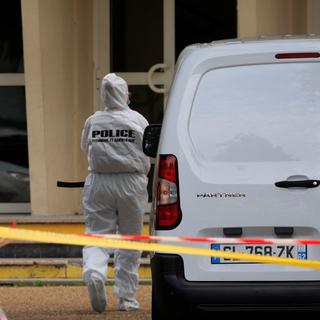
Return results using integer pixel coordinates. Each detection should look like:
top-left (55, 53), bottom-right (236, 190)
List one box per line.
top-left (93, 0), bottom-right (237, 205)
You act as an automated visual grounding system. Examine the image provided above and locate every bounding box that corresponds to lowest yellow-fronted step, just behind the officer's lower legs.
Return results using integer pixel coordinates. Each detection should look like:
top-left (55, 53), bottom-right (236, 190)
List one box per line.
top-left (0, 258), bottom-right (151, 284)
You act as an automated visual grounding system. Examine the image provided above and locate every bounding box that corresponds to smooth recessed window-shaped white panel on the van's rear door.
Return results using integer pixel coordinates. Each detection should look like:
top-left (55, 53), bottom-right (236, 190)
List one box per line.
top-left (189, 62), bottom-right (320, 162)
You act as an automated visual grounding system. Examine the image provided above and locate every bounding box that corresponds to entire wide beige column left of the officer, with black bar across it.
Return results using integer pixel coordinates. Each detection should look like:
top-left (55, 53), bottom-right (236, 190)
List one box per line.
top-left (21, 0), bottom-right (92, 215)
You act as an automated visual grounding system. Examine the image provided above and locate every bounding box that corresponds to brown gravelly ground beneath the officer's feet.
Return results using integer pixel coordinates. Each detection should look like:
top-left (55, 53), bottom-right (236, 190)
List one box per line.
top-left (0, 285), bottom-right (151, 320)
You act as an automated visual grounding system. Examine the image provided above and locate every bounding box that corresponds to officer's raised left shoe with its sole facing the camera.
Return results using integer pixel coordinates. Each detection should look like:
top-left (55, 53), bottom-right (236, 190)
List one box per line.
top-left (87, 276), bottom-right (107, 313)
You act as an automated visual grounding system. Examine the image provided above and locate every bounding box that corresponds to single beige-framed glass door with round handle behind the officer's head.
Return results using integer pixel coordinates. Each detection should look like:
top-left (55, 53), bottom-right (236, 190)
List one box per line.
top-left (94, 0), bottom-right (175, 205)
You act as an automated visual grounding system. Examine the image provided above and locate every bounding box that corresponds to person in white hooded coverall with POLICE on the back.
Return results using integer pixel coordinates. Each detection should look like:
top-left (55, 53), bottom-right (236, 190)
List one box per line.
top-left (81, 73), bottom-right (150, 312)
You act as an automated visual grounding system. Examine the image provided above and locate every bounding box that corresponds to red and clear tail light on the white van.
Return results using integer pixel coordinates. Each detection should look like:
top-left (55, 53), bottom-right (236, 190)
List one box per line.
top-left (155, 155), bottom-right (182, 230)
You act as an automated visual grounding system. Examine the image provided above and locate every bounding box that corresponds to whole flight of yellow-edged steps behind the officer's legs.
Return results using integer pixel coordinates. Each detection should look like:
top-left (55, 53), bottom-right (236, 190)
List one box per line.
top-left (0, 215), bottom-right (151, 284)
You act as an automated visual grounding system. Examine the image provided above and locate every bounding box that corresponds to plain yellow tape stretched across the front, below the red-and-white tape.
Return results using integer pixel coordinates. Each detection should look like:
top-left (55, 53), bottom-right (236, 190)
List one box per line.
top-left (0, 227), bottom-right (320, 269)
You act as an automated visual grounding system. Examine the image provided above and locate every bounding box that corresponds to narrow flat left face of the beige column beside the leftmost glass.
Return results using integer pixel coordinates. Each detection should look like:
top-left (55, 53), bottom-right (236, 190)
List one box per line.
top-left (21, 0), bottom-right (48, 213)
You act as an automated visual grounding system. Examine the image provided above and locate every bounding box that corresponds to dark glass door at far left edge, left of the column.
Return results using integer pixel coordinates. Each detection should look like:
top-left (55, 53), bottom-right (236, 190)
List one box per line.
top-left (0, 0), bottom-right (30, 215)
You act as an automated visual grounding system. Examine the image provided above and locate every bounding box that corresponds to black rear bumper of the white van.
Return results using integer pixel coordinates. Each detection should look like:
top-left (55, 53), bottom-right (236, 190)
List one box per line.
top-left (151, 254), bottom-right (320, 314)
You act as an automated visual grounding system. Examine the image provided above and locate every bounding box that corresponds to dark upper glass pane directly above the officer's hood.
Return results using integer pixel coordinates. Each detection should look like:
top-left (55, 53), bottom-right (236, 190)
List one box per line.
top-left (110, 0), bottom-right (163, 72)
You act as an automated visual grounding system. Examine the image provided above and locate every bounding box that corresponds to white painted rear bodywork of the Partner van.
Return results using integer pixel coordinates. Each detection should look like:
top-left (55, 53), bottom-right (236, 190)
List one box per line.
top-left (151, 38), bottom-right (320, 281)
